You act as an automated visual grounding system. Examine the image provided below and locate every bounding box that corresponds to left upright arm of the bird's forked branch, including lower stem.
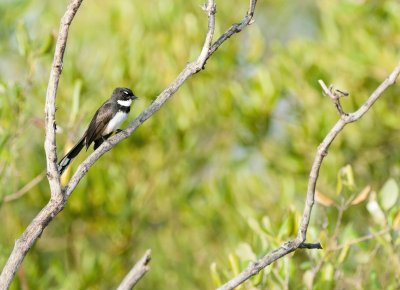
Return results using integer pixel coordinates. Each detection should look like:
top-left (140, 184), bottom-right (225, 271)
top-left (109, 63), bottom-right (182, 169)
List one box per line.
top-left (0, 0), bottom-right (82, 289)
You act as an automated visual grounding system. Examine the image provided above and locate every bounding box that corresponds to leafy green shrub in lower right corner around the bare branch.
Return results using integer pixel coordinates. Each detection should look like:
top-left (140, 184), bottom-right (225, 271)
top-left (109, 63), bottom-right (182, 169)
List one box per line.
top-left (213, 165), bottom-right (400, 289)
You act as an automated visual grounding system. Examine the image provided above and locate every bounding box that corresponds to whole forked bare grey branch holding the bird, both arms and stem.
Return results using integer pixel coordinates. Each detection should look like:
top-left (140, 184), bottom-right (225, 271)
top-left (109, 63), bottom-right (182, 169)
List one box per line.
top-left (0, 0), bottom-right (256, 290)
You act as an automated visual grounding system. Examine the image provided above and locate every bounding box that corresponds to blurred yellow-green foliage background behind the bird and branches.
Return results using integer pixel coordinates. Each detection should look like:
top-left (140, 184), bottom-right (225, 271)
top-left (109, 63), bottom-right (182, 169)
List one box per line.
top-left (0, 0), bottom-right (400, 290)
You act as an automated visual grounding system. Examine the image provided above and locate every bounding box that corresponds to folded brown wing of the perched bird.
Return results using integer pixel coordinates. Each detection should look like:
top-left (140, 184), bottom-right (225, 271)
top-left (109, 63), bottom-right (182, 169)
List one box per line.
top-left (85, 102), bottom-right (113, 149)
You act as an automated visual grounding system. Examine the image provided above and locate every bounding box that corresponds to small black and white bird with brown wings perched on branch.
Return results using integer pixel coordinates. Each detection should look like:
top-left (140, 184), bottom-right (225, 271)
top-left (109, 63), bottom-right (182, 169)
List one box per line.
top-left (58, 88), bottom-right (137, 175)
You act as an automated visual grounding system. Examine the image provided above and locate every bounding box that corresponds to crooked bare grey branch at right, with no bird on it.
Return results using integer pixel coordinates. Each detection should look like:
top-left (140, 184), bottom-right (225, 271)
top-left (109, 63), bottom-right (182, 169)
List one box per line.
top-left (218, 64), bottom-right (400, 290)
